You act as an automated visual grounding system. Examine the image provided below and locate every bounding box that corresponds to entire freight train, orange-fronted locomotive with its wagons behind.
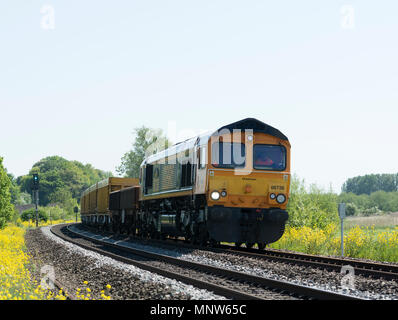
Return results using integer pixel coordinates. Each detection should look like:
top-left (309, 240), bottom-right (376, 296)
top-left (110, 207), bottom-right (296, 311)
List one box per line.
top-left (81, 118), bottom-right (291, 249)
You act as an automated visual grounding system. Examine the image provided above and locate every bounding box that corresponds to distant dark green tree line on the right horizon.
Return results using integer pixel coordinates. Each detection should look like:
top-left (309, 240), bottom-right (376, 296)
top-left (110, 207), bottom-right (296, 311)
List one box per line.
top-left (341, 173), bottom-right (398, 195)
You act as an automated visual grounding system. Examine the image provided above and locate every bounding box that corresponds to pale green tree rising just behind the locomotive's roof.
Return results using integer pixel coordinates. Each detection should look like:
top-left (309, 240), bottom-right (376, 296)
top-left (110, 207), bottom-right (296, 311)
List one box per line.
top-left (116, 126), bottom-right (172, 178)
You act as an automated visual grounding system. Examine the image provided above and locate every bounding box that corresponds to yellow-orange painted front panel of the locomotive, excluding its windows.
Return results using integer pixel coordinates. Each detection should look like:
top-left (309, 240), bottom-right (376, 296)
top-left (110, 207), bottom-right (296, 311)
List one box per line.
top-left (206, 133), bottom-right (290, 209)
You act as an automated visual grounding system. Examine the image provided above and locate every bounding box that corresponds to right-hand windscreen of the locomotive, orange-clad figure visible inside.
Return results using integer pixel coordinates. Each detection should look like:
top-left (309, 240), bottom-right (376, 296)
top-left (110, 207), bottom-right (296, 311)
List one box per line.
top-left (253, 144), bottom-right (286, 171)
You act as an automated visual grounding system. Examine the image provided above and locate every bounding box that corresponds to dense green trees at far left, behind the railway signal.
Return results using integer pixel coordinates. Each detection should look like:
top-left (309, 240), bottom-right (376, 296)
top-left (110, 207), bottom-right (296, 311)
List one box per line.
top-left (0, 156), bottom-right (112, 229)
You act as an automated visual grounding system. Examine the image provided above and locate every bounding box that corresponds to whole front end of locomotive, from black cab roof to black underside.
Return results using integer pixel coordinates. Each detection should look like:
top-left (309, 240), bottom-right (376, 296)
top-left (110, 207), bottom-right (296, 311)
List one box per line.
top-left (206, 119), bottom-right (290, 247)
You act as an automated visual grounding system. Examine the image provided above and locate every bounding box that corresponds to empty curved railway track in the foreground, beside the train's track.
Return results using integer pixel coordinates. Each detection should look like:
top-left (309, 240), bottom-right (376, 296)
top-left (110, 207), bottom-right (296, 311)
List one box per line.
top-left (51, 225), bottom-right (360, 300)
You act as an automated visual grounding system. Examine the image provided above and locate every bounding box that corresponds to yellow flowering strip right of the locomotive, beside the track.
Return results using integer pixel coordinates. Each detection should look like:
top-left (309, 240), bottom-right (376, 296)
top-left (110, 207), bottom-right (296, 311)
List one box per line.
top-left (270, 224), bottom-right (398, 262)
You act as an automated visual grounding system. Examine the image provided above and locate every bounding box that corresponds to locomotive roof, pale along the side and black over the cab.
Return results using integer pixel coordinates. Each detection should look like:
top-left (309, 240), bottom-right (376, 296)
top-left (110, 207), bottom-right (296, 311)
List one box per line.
top-left (141, 118), bottom-right (289, 165)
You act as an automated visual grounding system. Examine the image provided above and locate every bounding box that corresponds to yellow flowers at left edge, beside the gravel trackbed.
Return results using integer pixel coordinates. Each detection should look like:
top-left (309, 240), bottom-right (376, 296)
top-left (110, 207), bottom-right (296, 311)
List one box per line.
top-left (0, 220), bottom-right (110, 300)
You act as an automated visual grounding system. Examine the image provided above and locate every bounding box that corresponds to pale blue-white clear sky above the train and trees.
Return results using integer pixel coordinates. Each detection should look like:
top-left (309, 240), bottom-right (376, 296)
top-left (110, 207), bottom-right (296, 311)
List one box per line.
top-left (0, 0), bottom-right (398, 192)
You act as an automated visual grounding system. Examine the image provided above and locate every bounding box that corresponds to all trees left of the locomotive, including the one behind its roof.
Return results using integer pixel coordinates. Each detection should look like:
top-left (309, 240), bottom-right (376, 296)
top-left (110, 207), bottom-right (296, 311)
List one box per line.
top-left (0, 127), bottom-right (166, 229)
